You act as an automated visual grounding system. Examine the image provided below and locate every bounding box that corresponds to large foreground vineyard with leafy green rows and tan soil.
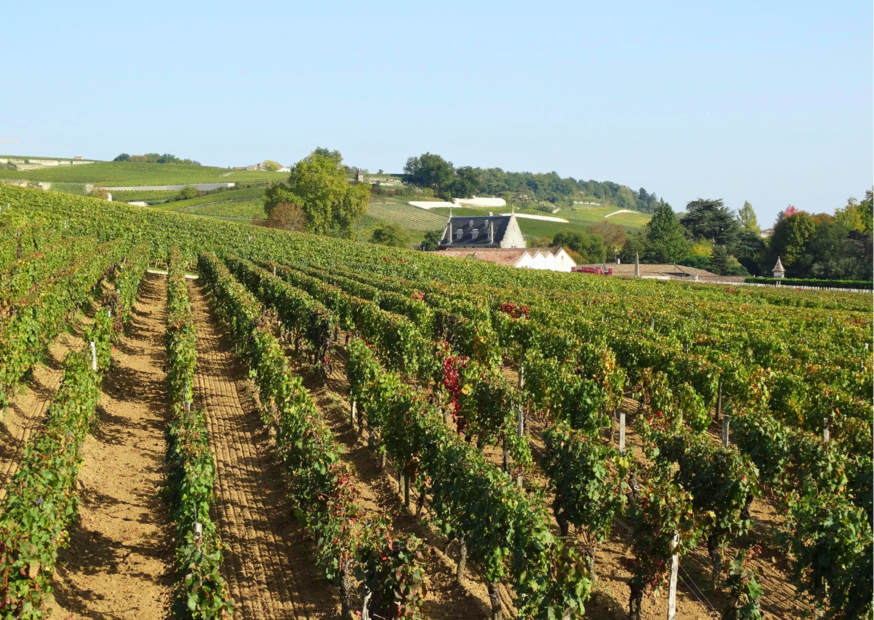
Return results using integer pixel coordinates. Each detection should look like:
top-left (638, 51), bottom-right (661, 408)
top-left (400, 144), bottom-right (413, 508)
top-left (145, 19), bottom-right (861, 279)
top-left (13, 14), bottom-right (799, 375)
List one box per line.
top-left (0, 184), bottom-right (874, 620)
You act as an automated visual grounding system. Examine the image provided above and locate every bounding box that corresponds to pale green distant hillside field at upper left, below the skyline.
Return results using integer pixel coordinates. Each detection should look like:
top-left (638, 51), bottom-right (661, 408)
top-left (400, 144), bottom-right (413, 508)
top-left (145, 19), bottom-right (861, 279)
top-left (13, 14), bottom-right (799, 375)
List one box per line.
top-left (0, 162), bottom-right (288, 185)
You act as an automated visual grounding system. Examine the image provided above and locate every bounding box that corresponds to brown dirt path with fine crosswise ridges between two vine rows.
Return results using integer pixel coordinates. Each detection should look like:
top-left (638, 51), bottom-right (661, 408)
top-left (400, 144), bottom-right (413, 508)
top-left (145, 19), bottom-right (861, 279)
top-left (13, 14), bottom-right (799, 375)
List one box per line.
top-left (188, 283), bottom-right (340, 620)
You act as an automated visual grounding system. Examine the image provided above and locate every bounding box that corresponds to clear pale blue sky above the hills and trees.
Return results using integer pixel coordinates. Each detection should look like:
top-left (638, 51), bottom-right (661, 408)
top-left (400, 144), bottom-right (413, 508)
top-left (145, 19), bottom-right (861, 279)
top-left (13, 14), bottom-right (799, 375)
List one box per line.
top-left (0, 0), bottom-right (874, 225)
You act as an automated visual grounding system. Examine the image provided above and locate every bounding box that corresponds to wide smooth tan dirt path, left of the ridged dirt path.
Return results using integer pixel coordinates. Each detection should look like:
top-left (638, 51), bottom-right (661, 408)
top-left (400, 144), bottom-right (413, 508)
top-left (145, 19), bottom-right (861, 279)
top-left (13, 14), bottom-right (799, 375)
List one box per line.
top-left (51, 276), bottom-right (173, 620)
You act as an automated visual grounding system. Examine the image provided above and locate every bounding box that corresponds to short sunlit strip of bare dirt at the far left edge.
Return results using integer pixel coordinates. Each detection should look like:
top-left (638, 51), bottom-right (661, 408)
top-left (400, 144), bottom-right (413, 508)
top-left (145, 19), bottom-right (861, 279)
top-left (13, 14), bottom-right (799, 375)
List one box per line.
top-left (0, 315), bottom-right (90, 501)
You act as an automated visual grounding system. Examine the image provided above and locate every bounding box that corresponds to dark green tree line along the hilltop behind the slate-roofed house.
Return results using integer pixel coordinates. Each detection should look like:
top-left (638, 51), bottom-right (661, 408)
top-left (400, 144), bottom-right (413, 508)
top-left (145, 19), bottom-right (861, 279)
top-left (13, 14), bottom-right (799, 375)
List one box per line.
top-left (404, 153), bottom-right (663, 213)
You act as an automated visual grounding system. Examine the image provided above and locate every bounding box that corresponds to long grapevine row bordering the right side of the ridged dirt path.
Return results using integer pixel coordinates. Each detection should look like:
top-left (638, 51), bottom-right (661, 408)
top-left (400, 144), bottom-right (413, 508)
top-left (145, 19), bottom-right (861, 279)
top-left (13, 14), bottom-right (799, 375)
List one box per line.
top-left (198, 254), bottom-right (425, 620)
